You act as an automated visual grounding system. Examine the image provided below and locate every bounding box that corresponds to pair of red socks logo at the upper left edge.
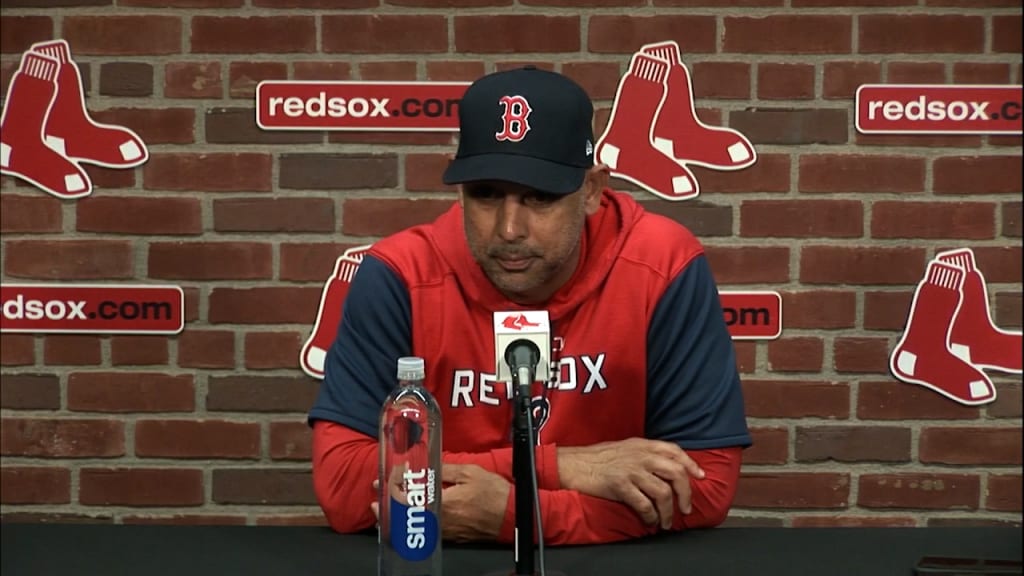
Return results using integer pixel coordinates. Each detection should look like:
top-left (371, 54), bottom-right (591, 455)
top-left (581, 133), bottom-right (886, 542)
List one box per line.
top-left (0, 40), bottom-right (150, 199)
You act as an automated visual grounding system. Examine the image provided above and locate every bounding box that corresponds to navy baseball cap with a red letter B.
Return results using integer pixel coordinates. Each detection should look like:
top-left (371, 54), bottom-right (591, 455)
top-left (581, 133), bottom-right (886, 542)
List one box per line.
top-left (443, 67), bottom-right (594, 194)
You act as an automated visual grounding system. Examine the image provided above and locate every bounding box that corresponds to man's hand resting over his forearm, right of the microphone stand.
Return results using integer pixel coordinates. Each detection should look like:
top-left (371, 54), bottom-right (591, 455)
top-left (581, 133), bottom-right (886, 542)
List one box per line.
top-left (558, 438), bottom-right (703, 529)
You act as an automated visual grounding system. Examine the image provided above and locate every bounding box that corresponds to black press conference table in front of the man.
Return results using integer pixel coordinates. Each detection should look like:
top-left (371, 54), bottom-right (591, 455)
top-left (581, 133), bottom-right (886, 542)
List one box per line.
top-left (0, 524), bottom-right (1021, 576)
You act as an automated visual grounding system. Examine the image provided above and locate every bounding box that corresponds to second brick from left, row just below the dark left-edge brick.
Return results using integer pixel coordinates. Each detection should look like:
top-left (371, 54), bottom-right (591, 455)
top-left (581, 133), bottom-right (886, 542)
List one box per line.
top-left (135, 420), bottom-right (260, 459)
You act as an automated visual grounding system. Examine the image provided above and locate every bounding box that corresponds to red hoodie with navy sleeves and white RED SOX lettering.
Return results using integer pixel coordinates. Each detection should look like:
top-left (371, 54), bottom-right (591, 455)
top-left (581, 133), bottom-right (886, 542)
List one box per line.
top-left (309, 191), bottom-right (751, 544)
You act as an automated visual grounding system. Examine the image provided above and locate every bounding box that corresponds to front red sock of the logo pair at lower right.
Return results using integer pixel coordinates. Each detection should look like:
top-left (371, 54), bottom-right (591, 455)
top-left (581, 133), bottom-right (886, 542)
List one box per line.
top-left (889, 260), bottom-right (995, 405)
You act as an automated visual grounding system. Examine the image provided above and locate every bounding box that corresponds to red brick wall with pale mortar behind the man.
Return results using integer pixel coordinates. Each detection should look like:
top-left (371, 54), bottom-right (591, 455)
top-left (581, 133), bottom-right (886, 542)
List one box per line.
top-left (0, 0), bottom-right (1022, 526)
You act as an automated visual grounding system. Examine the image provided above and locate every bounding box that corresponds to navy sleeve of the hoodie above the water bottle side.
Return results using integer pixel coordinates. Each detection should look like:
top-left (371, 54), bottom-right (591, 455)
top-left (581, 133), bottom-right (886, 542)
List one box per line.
top-left (309, 255), bottom-right (413, 438)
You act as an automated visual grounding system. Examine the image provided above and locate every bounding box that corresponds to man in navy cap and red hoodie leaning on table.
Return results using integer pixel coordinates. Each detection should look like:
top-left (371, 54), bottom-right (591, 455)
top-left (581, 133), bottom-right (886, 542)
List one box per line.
top-left (309, 67), bottom-right (751, 544)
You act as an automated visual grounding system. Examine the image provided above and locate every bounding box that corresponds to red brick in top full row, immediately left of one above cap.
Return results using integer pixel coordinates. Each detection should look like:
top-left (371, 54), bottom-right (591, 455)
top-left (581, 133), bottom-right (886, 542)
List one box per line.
top-left (321, 14), bottom-right (444, 54)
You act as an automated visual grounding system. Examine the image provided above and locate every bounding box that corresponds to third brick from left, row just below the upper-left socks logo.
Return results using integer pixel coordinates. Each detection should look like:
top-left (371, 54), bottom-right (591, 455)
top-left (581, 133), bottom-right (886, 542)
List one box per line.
top-left (213, 198), bottom-right (337, 231)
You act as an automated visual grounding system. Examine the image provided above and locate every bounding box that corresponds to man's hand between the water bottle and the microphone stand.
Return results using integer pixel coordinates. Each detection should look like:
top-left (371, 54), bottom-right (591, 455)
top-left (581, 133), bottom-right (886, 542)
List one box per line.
top-left (441, 464), bottom-right (512, 542)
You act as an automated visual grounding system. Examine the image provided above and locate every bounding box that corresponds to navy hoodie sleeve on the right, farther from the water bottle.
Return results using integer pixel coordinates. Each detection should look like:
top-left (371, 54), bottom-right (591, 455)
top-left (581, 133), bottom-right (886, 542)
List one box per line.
top-left (646, 255), bottom-right (752, 450)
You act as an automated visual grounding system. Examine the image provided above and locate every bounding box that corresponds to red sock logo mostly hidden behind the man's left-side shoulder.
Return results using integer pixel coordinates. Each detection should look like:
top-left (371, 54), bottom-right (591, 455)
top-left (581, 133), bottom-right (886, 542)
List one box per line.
top-left (299, 244), bottom-right (371, 379)
